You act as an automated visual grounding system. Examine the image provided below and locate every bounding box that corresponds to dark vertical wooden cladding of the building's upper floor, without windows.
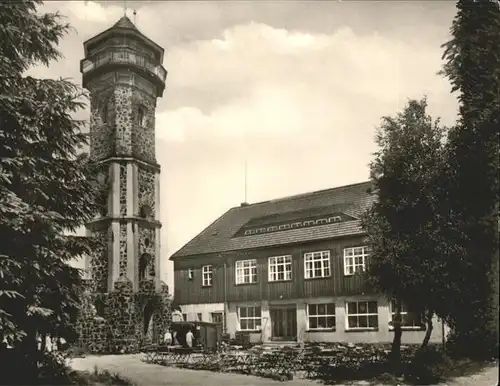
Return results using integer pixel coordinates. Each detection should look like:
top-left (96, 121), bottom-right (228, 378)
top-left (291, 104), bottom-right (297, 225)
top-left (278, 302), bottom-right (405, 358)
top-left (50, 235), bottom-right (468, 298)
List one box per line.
top-left (174, 236), bottom-right (369, 304)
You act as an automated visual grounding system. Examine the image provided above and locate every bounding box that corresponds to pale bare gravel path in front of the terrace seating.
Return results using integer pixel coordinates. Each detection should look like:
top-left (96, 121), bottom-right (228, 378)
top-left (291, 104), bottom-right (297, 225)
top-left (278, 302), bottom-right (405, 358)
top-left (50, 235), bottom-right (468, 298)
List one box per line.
top-left (71, 354), bottom-right (498, 386)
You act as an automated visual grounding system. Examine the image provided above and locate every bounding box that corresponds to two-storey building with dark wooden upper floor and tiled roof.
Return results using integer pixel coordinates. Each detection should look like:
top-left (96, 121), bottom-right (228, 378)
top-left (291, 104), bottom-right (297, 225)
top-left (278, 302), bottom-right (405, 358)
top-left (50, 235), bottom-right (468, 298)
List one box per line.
top-left (171, 182), bottom-right (441, 343)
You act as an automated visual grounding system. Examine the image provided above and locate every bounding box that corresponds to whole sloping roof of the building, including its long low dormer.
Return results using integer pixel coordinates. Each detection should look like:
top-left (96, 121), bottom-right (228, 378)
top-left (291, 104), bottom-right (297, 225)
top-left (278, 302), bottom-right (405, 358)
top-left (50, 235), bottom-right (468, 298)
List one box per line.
top-left (170, 182), bottom-right (375, 260)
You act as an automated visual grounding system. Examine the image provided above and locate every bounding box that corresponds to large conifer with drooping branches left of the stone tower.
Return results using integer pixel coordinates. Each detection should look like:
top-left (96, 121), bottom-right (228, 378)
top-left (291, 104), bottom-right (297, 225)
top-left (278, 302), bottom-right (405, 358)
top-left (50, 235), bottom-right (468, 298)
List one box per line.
top-left (0, 1), bottom-right (96, 377)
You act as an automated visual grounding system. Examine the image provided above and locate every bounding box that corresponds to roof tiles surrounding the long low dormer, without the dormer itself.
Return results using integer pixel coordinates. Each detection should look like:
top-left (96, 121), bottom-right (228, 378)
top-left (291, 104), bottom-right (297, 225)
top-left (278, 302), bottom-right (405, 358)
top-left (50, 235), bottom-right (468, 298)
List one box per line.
top-left (171, 182), bottom-right (375, 259)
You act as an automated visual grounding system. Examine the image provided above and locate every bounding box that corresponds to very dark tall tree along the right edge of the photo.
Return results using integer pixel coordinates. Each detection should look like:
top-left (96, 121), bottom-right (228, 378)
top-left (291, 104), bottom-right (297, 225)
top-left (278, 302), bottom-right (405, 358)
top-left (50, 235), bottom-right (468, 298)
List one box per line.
top-left (443, 0), bottom-right (500, 357)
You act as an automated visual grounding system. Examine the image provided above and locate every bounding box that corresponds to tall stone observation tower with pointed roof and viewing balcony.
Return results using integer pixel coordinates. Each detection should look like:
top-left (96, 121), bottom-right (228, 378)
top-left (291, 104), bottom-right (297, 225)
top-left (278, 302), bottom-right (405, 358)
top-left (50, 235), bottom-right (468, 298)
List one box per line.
top-left (80, 16), bottom-right (170, 352)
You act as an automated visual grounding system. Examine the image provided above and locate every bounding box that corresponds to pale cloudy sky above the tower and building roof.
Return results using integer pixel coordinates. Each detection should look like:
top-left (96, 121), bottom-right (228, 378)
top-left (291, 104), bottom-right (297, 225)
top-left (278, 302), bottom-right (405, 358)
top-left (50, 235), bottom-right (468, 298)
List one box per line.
top-left (32, 0), bottom-right (457, 285)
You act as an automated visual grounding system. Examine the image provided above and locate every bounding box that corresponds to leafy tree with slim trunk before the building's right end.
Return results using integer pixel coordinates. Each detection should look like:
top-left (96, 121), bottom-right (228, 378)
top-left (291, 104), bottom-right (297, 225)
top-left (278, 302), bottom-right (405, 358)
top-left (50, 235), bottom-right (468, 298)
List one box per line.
top-left (362, 98), bottom-right (446, 366)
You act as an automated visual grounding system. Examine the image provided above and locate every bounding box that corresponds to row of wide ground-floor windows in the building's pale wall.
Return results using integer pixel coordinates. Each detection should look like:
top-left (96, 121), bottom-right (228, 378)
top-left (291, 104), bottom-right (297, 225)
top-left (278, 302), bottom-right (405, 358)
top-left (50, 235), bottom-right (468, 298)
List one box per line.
top-left (238, 301), bottom-right (424, 331)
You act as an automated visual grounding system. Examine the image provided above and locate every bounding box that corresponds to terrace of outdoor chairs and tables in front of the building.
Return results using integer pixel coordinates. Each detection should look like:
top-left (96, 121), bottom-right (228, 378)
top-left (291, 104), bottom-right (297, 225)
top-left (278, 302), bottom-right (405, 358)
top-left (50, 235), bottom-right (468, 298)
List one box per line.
top-left (142, 344), bottom-right (416, 381)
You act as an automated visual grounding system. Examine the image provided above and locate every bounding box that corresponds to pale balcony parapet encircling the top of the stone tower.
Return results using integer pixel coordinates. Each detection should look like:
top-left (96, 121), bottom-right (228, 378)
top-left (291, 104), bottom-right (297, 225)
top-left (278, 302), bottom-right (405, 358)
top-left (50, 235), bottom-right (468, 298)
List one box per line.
top-left (81, 49), bottom-right (167, 83)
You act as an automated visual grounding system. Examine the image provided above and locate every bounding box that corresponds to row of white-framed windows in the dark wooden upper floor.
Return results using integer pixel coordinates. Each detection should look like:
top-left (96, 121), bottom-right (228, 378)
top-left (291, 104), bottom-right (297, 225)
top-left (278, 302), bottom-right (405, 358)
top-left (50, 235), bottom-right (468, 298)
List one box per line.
top-left (188, 246), bottom-right (369, 286)
